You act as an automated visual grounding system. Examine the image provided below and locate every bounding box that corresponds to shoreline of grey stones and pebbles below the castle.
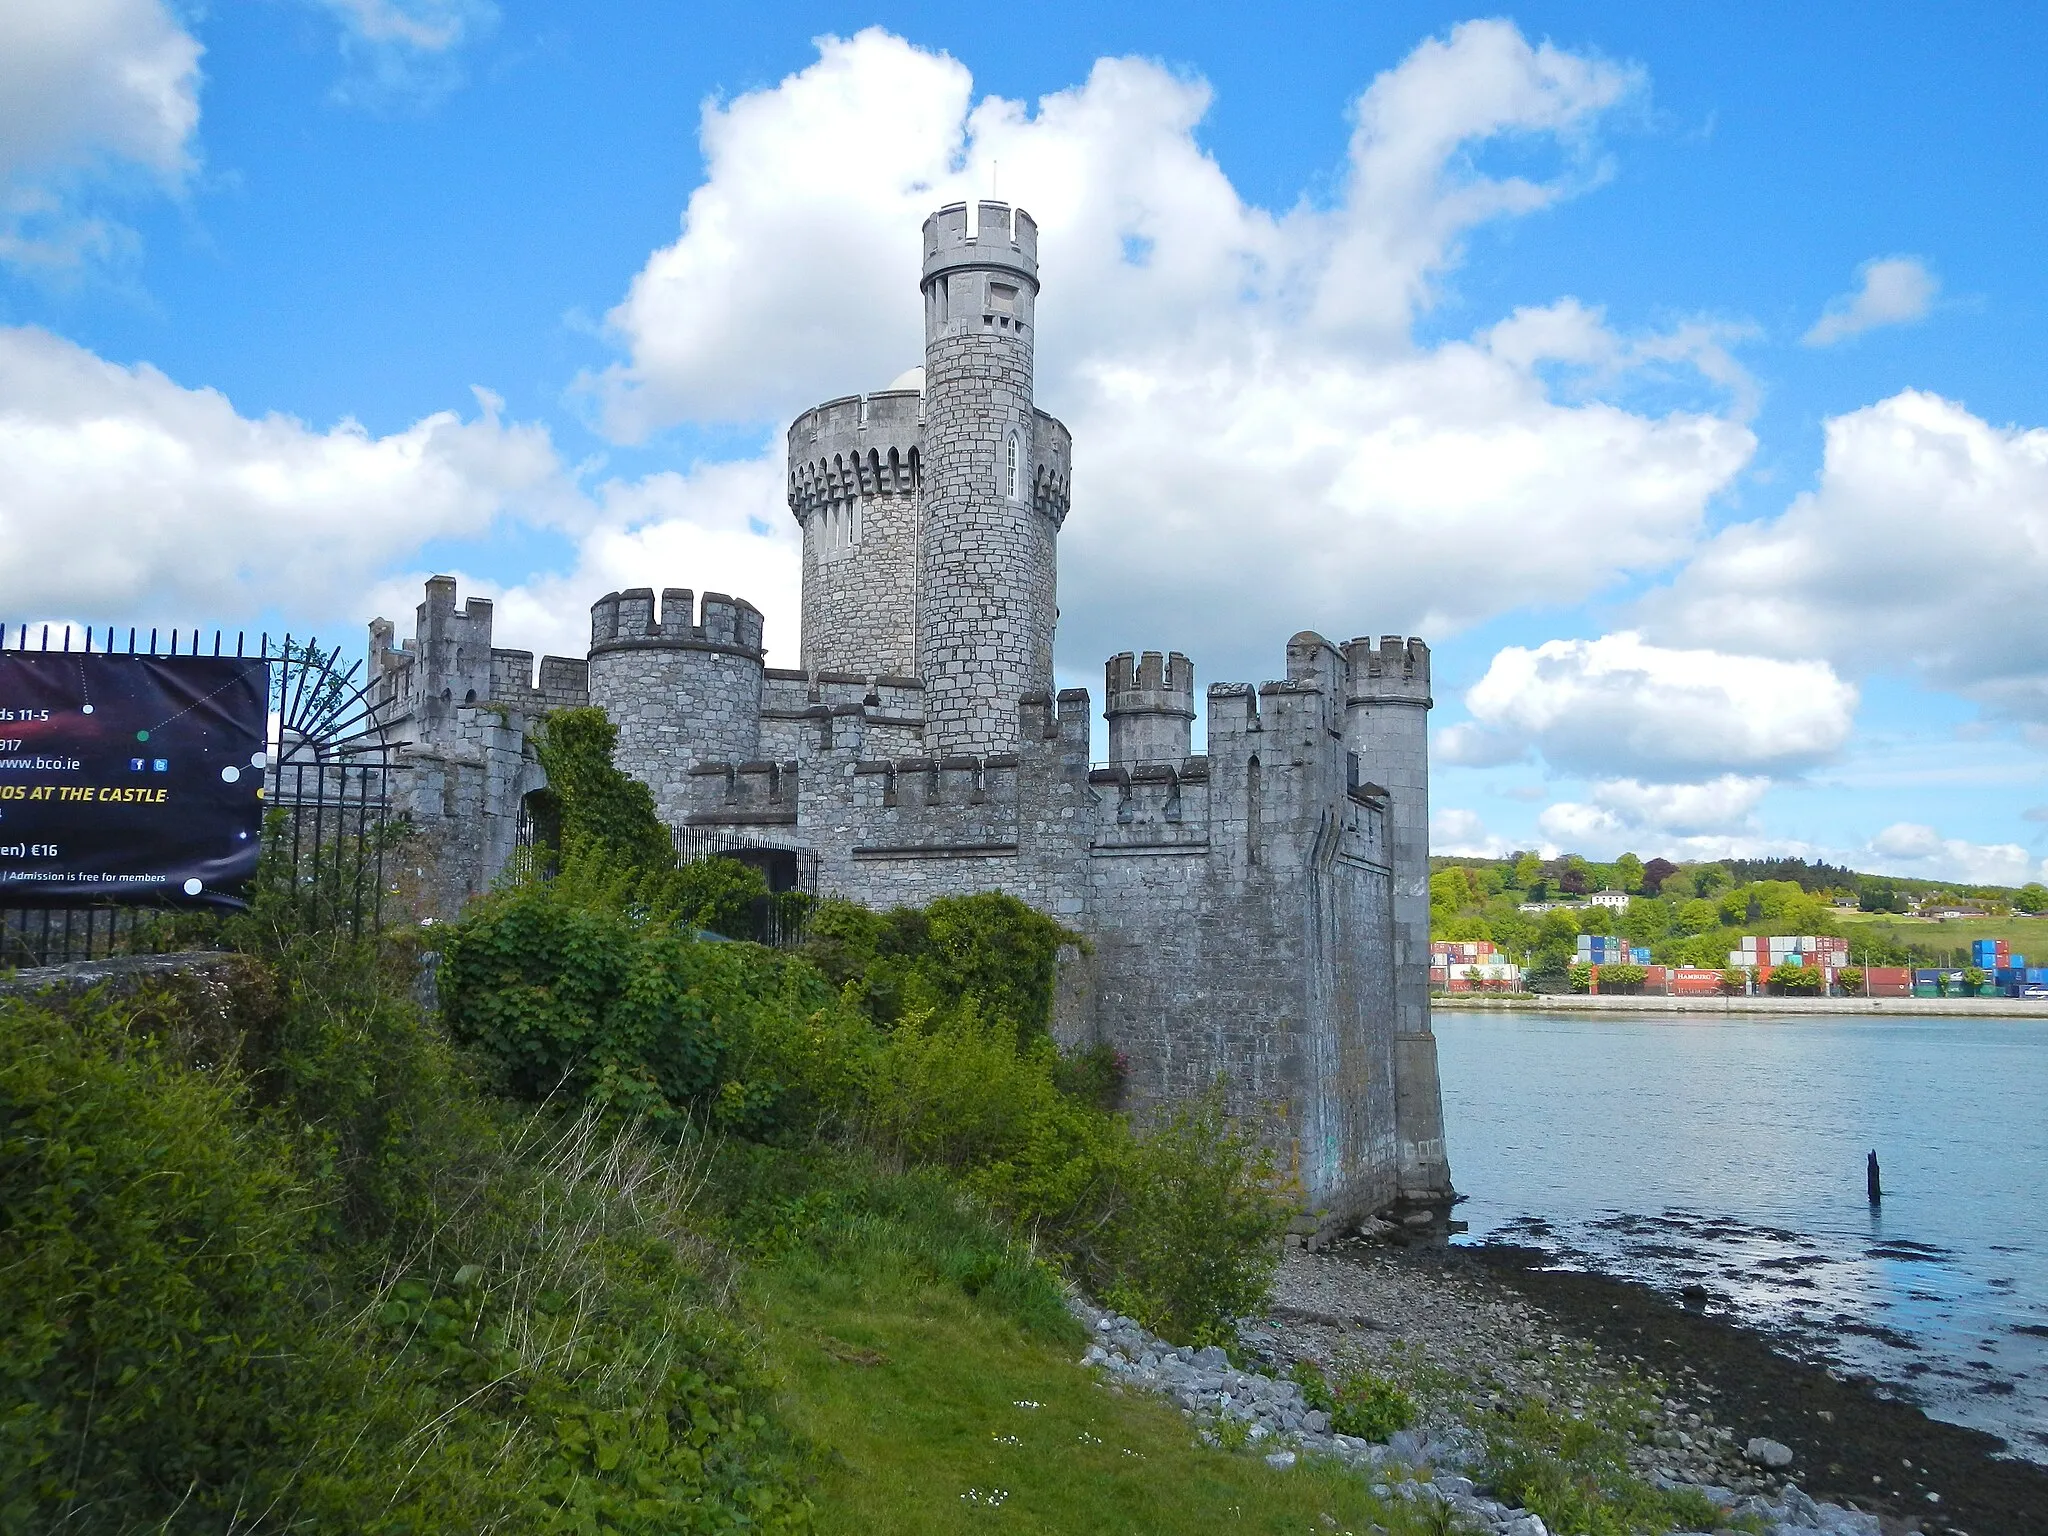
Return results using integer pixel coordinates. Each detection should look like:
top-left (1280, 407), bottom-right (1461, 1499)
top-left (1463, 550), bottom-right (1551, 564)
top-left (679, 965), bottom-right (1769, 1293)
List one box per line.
top-left (1075, 1241), bottom-right (2048, 1536)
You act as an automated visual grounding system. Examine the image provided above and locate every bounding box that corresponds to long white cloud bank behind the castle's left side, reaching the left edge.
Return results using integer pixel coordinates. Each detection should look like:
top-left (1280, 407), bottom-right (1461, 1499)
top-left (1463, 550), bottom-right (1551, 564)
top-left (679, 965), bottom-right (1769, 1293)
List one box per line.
top-left (0, 328), bottom-right (799, 666)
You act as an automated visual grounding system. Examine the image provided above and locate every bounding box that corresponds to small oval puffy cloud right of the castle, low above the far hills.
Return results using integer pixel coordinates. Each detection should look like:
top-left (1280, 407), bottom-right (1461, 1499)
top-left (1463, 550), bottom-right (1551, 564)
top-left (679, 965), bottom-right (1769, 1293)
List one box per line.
top-left (1438, 631), bottom-right (1858, 782)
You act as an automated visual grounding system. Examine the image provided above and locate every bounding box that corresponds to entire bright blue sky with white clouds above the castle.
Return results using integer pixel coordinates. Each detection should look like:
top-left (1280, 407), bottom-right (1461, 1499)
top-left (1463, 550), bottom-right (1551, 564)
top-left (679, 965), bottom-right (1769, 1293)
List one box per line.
top-left (0, 0), bottom-right (2048, 881)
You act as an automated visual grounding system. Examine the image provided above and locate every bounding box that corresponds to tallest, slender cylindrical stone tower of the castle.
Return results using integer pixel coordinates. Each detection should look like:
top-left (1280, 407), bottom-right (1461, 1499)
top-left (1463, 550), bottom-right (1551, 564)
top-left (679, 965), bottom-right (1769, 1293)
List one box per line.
top-left (918, 203), bottom-right (1071, 754)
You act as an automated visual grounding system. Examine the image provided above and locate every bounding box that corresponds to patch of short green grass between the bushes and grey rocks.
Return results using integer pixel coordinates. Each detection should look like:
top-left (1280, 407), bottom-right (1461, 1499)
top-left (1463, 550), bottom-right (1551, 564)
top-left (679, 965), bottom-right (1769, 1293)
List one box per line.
top-left (748, 1180), bottom-right (1438, 1536)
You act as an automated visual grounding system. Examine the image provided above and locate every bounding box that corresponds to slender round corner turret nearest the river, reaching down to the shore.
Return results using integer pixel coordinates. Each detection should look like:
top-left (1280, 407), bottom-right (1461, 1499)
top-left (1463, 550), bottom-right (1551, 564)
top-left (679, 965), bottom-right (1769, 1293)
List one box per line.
top-left (1343, 635), bottom-right (1450, 1200)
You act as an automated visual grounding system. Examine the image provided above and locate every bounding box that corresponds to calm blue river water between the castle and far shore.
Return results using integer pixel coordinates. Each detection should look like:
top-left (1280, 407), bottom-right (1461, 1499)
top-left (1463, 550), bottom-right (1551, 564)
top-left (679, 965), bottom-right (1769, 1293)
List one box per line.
top-left (1434, 1010), bottom-right (2048, 1462)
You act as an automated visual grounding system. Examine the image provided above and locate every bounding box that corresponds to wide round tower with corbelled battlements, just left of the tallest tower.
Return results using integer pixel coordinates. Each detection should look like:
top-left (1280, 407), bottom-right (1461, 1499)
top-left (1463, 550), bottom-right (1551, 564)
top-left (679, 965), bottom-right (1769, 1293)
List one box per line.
top-left (788, 389), bottom-right (924, 678)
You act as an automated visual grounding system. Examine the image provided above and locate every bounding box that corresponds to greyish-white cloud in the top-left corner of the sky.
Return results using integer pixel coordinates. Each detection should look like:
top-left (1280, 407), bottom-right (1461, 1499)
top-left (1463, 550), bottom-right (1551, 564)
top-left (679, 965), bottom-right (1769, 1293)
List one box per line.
top-left (0, 0), bottom-right (201, 268)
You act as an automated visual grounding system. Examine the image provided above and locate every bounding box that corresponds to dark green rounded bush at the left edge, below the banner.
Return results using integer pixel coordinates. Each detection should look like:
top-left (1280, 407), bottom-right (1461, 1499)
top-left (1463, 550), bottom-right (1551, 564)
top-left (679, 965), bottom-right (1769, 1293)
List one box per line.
top-left (0, 987), bottom-right (326, 1530)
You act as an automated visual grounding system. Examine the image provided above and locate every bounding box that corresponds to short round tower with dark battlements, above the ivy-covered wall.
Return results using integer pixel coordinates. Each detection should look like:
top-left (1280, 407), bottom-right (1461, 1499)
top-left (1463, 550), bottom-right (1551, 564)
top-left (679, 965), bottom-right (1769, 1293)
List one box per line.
top-left (590, 586), bottom-right (764, 825)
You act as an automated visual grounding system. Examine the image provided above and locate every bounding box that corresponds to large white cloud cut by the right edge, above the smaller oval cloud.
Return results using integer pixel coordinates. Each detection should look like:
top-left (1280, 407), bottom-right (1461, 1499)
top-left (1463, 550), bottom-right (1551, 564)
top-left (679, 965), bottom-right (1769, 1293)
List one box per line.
top-left (1640, 389), bottom-right (2048, 723)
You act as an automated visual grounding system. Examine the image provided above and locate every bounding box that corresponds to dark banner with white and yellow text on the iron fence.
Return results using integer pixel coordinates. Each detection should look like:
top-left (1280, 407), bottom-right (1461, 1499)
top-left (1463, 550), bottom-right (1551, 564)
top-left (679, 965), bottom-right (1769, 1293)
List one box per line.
top-left (0, 651), bottom-right (270, 907)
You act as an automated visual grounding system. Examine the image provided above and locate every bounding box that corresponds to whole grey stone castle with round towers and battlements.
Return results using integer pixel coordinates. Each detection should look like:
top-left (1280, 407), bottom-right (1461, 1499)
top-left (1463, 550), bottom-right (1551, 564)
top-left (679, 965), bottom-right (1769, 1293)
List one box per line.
top-left (371, 203), bottom-right (1450, 1221)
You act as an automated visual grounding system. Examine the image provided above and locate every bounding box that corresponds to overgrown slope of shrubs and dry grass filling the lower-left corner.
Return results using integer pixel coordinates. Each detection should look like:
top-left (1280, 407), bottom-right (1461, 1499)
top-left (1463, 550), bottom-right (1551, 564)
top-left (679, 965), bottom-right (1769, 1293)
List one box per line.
top-left (0, 958), bottom-right (809, 1536)
